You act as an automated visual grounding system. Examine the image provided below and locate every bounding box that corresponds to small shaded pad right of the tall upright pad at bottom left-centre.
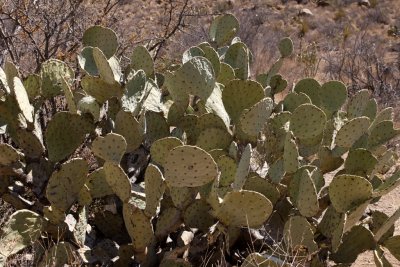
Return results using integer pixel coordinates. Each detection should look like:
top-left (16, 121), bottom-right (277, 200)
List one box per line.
top-left (155, 208), bottom-right (182, 239)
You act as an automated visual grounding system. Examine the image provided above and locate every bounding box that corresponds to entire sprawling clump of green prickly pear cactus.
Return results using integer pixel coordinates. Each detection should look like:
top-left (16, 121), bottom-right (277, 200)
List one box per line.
top-left (0, 14), bottom-right (400, 266)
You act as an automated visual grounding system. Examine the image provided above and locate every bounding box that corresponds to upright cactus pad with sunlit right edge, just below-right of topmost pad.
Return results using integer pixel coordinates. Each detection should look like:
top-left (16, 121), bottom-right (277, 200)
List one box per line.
top-left (224, 42), bottom-right (250, 80)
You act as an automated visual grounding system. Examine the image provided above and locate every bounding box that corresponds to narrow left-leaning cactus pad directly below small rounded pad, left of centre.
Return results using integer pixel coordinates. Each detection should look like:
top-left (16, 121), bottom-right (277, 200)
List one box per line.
top-left (103, 162), bottom-right (131, 202)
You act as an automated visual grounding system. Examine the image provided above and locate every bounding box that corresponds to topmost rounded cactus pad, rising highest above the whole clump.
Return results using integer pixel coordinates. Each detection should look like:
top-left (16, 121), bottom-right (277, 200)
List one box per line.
top-left (209, 14), bottom-right (239, 46)
